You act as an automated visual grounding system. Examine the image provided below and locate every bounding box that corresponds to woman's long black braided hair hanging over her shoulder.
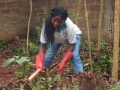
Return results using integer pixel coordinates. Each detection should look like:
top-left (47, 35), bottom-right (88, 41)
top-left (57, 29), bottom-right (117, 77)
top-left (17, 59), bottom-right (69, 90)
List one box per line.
top-left (44, 6), bottom-right (68, 43)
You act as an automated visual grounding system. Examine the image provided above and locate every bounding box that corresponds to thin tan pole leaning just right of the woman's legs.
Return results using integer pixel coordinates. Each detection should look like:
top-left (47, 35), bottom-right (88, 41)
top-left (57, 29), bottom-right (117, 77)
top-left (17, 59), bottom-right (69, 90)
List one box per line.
top-left (84, 0), bottom-right (93, 73)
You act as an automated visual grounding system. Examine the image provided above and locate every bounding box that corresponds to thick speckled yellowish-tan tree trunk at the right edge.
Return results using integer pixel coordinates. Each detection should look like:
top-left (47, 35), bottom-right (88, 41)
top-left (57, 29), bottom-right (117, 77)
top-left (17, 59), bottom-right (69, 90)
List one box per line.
top-left (112, 0), bottom-right (120, 82)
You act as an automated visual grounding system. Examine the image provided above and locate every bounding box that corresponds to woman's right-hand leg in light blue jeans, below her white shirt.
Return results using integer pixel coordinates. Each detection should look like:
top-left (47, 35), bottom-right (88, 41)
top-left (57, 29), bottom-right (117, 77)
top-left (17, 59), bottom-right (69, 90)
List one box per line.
top-left (72, 35), bottom-right (84, 74)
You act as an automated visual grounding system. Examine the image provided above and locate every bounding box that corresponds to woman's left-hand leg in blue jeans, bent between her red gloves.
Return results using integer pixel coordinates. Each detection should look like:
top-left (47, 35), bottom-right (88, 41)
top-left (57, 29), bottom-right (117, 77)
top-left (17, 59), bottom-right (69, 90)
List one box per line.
top-left (44, 42), bottom-right (62, 68)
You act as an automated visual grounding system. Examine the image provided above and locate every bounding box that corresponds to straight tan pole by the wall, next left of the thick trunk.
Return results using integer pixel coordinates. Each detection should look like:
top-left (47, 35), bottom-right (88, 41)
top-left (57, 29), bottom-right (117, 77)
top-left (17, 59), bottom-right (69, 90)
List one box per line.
top-left (97, 0), bottom-right (104, 50)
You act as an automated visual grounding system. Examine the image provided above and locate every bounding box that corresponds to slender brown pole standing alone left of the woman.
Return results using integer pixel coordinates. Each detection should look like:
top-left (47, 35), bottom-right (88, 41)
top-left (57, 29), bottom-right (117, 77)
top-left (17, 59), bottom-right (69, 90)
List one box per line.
top-left (27, 0), bottom-right (32, 56)
